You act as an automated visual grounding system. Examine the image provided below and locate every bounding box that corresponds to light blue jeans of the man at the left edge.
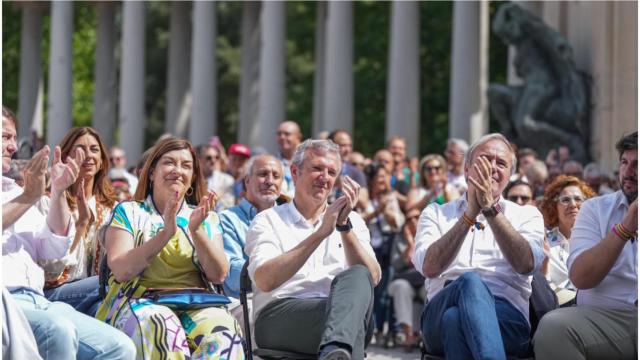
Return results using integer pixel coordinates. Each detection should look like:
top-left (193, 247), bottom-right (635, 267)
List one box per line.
top-left (12, 289), bottom-right (136, 360)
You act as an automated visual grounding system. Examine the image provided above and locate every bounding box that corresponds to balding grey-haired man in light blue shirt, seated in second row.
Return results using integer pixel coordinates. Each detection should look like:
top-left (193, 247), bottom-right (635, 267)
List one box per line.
top-left (220, 155), bottom-right (284, 298)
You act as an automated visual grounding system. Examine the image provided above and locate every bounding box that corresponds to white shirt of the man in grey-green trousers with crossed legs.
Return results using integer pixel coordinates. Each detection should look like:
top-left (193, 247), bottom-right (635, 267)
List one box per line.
top-left (245, 202), bottom-right (375, 319)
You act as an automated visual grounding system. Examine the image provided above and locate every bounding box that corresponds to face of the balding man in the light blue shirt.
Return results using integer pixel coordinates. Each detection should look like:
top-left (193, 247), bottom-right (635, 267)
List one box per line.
top-left (245, 155), bottom-right (284, 207)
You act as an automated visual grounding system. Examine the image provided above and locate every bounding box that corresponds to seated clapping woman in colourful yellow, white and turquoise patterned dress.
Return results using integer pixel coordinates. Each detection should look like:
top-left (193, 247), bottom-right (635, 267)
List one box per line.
top-left (96, 137), bottom-right (244, 359)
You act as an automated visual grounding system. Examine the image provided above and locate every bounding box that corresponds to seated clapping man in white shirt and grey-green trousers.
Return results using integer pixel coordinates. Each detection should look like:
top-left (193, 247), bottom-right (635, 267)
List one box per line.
top-left (246, 140), bottom-right (380, 360)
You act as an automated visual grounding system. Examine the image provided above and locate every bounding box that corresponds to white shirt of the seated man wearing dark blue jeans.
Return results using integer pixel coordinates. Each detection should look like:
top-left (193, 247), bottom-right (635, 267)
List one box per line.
top-left (412, 195), bottom-right (544, 319)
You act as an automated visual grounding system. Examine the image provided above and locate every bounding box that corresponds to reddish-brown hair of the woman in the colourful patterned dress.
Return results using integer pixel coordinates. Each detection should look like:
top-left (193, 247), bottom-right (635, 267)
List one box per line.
top-left (133, 136), bottom-right (207, 205)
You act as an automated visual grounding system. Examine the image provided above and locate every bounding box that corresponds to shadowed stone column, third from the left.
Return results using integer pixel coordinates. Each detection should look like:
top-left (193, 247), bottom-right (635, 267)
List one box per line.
top-left (92, 1), bottom-right (116, 147)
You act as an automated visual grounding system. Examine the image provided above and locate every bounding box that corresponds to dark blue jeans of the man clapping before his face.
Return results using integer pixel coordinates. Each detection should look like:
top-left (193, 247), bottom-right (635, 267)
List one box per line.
top-left (422, 272), bottom-right (531, 359)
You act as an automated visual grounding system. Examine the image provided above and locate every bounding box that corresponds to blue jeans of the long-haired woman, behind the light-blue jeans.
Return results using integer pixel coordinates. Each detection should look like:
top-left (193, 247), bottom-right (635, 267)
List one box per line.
top-left (44, 275), bottom-right (100, 317)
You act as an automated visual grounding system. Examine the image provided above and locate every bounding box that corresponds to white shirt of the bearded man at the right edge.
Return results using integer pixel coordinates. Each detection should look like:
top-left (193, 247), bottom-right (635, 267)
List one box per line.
top-left (567, 191), bottom-right (638, 308)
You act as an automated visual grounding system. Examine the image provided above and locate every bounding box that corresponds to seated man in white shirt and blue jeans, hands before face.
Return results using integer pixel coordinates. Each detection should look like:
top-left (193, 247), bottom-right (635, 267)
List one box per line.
top-left (413, 134), bottom-right (544, 359)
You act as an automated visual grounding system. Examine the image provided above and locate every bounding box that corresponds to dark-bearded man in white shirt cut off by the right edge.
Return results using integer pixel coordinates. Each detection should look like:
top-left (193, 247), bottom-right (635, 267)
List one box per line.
top-left (534, 131), bottom-right (638, 360)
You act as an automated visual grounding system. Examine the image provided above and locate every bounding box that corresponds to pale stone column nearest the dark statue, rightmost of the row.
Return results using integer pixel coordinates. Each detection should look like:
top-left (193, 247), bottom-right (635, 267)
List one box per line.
top-left (449, 1), bottom-right (489, 143)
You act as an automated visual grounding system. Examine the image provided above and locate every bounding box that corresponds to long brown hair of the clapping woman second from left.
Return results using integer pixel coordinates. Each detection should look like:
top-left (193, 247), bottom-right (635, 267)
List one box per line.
top-left (60, 126), bottom-right (117, 208)
